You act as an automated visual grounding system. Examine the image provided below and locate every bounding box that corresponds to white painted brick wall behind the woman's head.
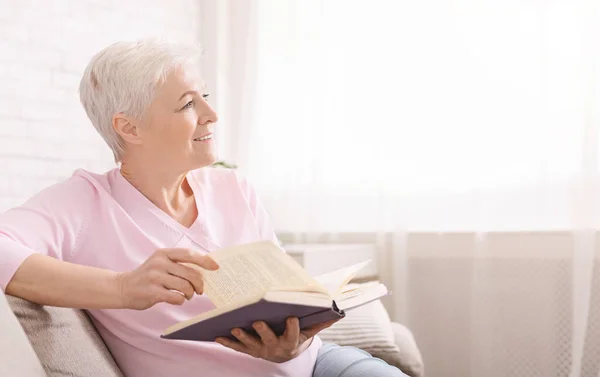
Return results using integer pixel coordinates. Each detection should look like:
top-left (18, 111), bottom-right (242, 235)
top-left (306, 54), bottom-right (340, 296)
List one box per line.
top-left (0, 0), bottom-right (200, 211)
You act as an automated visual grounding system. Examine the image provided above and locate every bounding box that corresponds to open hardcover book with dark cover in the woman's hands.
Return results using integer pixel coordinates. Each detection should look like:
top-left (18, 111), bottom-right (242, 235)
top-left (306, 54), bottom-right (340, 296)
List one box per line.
top-left (161, 241), bottom-right (388, 341)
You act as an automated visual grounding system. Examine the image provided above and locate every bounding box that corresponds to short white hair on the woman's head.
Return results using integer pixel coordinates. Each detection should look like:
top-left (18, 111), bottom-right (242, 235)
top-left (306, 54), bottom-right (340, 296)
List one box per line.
top-left (79, 38), bottom-right (202, 162)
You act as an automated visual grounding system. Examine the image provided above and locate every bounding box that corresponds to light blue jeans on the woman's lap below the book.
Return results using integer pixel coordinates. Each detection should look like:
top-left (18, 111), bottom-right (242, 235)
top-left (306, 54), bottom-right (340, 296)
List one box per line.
top-left (313, 343), bottom-right (407, 377)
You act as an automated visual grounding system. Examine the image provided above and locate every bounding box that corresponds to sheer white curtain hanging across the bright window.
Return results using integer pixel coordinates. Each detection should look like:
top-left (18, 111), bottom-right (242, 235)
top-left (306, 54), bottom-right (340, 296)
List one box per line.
top-left (202, 0), bottom-right (600, 377)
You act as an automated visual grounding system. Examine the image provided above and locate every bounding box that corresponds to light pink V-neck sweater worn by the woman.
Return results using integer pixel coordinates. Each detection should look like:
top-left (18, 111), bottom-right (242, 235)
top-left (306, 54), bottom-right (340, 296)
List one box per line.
top-left (0, 168), bottom-right (321, 377)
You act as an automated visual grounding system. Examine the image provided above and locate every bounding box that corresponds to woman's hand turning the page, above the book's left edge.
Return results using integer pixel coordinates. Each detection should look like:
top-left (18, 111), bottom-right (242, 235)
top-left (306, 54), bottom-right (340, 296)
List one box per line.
top-left (117, 249), bottom-right (219, 310)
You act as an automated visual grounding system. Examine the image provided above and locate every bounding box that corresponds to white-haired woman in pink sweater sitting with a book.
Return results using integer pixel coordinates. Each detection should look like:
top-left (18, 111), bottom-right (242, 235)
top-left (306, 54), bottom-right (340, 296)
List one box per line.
top-left (0, 40), bottom-right (404, 377)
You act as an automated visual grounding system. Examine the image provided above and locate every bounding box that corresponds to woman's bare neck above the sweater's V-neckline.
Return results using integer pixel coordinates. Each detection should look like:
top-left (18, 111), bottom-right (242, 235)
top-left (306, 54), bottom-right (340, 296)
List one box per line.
top-left (120, 155), bottom-right (196, 220)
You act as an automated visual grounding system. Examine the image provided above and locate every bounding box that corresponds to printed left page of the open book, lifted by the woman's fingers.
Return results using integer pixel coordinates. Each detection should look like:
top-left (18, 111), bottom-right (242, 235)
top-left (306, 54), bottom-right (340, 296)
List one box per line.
top-left (202, 241), bottom-right (324, 308)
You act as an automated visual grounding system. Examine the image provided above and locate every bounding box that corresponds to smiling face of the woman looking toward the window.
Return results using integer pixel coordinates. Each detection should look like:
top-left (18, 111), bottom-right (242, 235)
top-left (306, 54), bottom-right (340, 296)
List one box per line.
top-left (127, 68), bottom-right (217, 171)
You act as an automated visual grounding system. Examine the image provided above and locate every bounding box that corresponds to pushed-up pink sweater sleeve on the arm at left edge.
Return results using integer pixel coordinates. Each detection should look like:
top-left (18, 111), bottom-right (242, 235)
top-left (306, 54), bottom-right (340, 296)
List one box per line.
top-left (0, 176), bottom-right (93, 291)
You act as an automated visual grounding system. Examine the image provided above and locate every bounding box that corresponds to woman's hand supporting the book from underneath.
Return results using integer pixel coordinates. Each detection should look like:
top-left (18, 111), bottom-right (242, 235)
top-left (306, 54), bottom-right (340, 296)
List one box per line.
top-left (215, 317), bottom-right (339, 363)
